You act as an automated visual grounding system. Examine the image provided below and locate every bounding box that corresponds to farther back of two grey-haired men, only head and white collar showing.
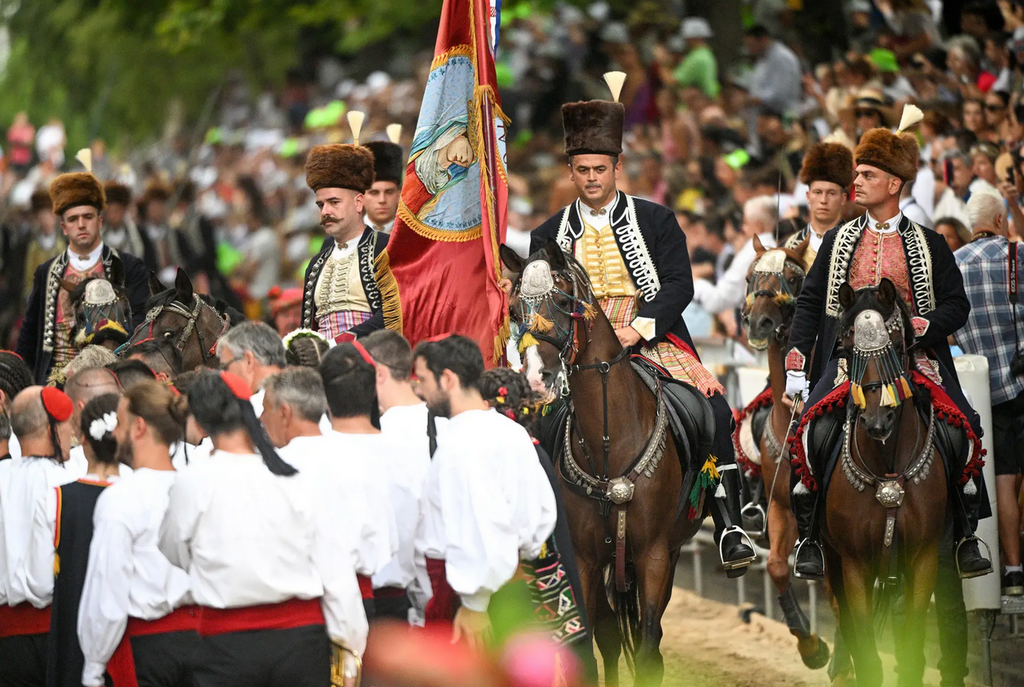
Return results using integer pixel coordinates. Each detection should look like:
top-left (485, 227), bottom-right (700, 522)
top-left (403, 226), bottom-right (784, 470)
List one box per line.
top-left (217, 321), bottom-right (288, 418)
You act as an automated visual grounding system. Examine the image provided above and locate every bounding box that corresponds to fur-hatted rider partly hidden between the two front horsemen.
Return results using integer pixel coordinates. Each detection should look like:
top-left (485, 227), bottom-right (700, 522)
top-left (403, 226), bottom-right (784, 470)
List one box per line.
top-left (785, 143), bottom-right (853, 269)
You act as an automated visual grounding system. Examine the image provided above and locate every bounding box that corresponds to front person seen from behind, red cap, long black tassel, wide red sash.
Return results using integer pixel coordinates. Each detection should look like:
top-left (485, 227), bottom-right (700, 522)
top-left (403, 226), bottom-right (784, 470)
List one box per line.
top-left (160, 372), bottom-right (366, 687)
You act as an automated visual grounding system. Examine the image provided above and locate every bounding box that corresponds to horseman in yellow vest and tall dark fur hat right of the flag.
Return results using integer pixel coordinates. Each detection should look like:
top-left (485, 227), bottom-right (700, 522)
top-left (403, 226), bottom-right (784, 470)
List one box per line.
top-left (530, 88), bottom-right (755, 574)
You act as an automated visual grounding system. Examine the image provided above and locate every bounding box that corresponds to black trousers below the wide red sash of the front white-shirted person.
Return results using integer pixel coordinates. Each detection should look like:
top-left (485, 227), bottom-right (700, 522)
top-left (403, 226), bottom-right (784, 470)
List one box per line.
top-left (192, 625), bottom-right (331, 687)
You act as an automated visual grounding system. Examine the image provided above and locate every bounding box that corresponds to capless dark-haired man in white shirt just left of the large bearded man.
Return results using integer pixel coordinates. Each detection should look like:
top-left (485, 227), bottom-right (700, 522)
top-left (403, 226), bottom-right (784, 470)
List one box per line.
top-left (362, 330), bottom-right (430, 621)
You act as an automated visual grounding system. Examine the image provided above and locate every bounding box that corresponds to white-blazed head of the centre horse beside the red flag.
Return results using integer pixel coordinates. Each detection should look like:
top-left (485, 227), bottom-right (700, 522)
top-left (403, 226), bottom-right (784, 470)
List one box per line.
top-left (500, 241), bottom-right (599, 397)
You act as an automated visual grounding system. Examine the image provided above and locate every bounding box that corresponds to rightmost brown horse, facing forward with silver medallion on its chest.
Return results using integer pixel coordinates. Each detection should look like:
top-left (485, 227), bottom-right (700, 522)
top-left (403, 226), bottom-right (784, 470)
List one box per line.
top-left (819, 278), bottom-right (947, 686)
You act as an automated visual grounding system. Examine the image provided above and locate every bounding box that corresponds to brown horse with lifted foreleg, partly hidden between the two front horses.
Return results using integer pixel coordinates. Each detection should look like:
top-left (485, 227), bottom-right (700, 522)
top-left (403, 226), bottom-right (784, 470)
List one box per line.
top-left (734, 237), bottom-right (829, 670)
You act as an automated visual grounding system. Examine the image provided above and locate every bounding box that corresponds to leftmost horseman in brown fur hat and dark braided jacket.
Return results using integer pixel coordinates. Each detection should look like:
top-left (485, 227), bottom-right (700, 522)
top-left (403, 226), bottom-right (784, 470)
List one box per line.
top-left (16, 172), bottom-right (150, 384)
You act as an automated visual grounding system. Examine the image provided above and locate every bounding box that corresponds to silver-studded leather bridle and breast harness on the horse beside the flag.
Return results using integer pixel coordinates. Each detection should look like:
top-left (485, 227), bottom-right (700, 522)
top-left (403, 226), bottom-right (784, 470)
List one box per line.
top-left (518, 260), bottom-right (669, 592)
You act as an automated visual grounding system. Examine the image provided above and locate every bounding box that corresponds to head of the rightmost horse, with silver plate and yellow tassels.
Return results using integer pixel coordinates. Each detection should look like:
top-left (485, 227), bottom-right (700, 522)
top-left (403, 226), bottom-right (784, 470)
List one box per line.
top-left (839, 278), bottom-right (914, 441)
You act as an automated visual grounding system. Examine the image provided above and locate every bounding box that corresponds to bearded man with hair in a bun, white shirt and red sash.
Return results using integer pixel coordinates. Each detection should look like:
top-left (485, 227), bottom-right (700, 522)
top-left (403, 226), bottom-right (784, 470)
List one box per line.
top-left (77, 382), bottom-right (199, 687)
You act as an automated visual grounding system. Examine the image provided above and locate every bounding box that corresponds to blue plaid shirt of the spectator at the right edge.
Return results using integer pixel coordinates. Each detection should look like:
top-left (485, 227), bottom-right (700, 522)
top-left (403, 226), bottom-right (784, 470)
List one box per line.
top-left (953, 237), bottom-right (1024, 405)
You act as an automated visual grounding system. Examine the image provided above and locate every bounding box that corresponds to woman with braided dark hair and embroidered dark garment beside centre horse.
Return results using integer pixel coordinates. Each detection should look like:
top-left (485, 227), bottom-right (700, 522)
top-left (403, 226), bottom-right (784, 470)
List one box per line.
top-left (480, 368), bottom-right (597, 681)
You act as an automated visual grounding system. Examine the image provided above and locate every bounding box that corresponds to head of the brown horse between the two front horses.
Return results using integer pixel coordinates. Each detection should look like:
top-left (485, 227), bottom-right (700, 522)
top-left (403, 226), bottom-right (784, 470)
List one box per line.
top-left (742, 237), bottom-right (809, 350)
